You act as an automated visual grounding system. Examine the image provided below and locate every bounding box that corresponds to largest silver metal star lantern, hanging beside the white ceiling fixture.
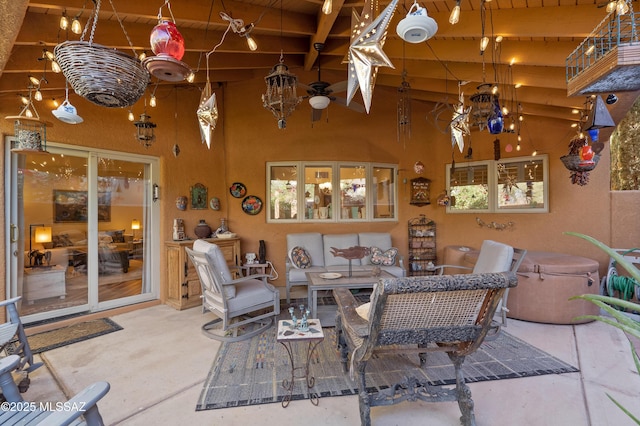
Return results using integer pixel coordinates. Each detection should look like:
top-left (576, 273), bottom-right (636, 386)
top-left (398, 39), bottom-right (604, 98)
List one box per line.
top-left (347, 0), bottom-right (398, 113)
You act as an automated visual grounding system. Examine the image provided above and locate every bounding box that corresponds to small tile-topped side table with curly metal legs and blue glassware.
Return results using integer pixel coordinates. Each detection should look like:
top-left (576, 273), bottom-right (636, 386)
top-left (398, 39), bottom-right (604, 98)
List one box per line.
top-left (276, 319), bottom-right (324, 408)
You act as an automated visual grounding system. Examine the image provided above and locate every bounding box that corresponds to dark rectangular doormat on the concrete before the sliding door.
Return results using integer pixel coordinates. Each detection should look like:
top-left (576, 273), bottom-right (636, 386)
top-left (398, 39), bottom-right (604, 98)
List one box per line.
top-left (27, 318), bottom-right (122, 354)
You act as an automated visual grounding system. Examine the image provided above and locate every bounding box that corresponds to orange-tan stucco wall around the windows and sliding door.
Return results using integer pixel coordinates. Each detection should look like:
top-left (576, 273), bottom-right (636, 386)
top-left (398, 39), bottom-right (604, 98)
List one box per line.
top-left (0, 70), bottom-right (620, 298)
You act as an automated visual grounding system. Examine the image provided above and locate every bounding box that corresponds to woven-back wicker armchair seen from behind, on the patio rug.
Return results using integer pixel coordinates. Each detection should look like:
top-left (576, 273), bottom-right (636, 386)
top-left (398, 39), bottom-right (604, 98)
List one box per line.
top-left (333, 272), bottom-right (518, 426)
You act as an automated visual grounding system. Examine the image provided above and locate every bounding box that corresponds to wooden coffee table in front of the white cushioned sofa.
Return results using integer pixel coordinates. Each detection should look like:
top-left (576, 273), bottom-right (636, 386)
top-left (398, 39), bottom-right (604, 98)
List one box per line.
top-left (306, 271), bottom-right (394, 327)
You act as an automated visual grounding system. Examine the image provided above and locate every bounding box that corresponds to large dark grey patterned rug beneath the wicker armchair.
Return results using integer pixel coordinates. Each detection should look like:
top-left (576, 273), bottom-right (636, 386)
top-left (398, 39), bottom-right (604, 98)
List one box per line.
top-left (196, 310), bottom-right (579, 411)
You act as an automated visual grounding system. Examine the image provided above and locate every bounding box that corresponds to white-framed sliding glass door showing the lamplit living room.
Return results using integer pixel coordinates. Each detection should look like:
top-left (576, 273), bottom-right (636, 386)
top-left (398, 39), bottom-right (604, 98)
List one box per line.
top-left (6, 139), bottom-right (159, 322)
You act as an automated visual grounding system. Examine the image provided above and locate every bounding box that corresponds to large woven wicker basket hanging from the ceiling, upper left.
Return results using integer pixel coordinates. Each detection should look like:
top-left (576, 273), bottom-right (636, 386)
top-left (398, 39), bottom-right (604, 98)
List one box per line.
top-left (53, 0), bottom-right (149, 108)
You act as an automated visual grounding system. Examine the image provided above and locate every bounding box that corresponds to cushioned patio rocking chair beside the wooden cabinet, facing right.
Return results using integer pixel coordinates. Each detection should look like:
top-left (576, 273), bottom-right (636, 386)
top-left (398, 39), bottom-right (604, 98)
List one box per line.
top-left (185, 240), bottom-right (280, 342)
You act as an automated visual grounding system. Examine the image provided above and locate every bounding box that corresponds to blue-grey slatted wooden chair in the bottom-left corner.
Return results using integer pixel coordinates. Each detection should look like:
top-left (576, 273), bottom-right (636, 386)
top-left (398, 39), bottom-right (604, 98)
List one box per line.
top-left (0, 355), bottom-right (110, 426)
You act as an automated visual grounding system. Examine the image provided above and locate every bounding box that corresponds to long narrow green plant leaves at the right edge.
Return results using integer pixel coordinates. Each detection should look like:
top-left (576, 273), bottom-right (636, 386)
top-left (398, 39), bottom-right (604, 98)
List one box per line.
top-left (565, 232), bottom-right (640, 425)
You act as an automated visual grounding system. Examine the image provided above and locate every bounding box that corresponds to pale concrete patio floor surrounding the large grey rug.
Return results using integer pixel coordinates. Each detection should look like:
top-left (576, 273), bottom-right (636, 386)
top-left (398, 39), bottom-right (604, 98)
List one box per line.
top-left (23, 305), bottom-right (640, 426)
